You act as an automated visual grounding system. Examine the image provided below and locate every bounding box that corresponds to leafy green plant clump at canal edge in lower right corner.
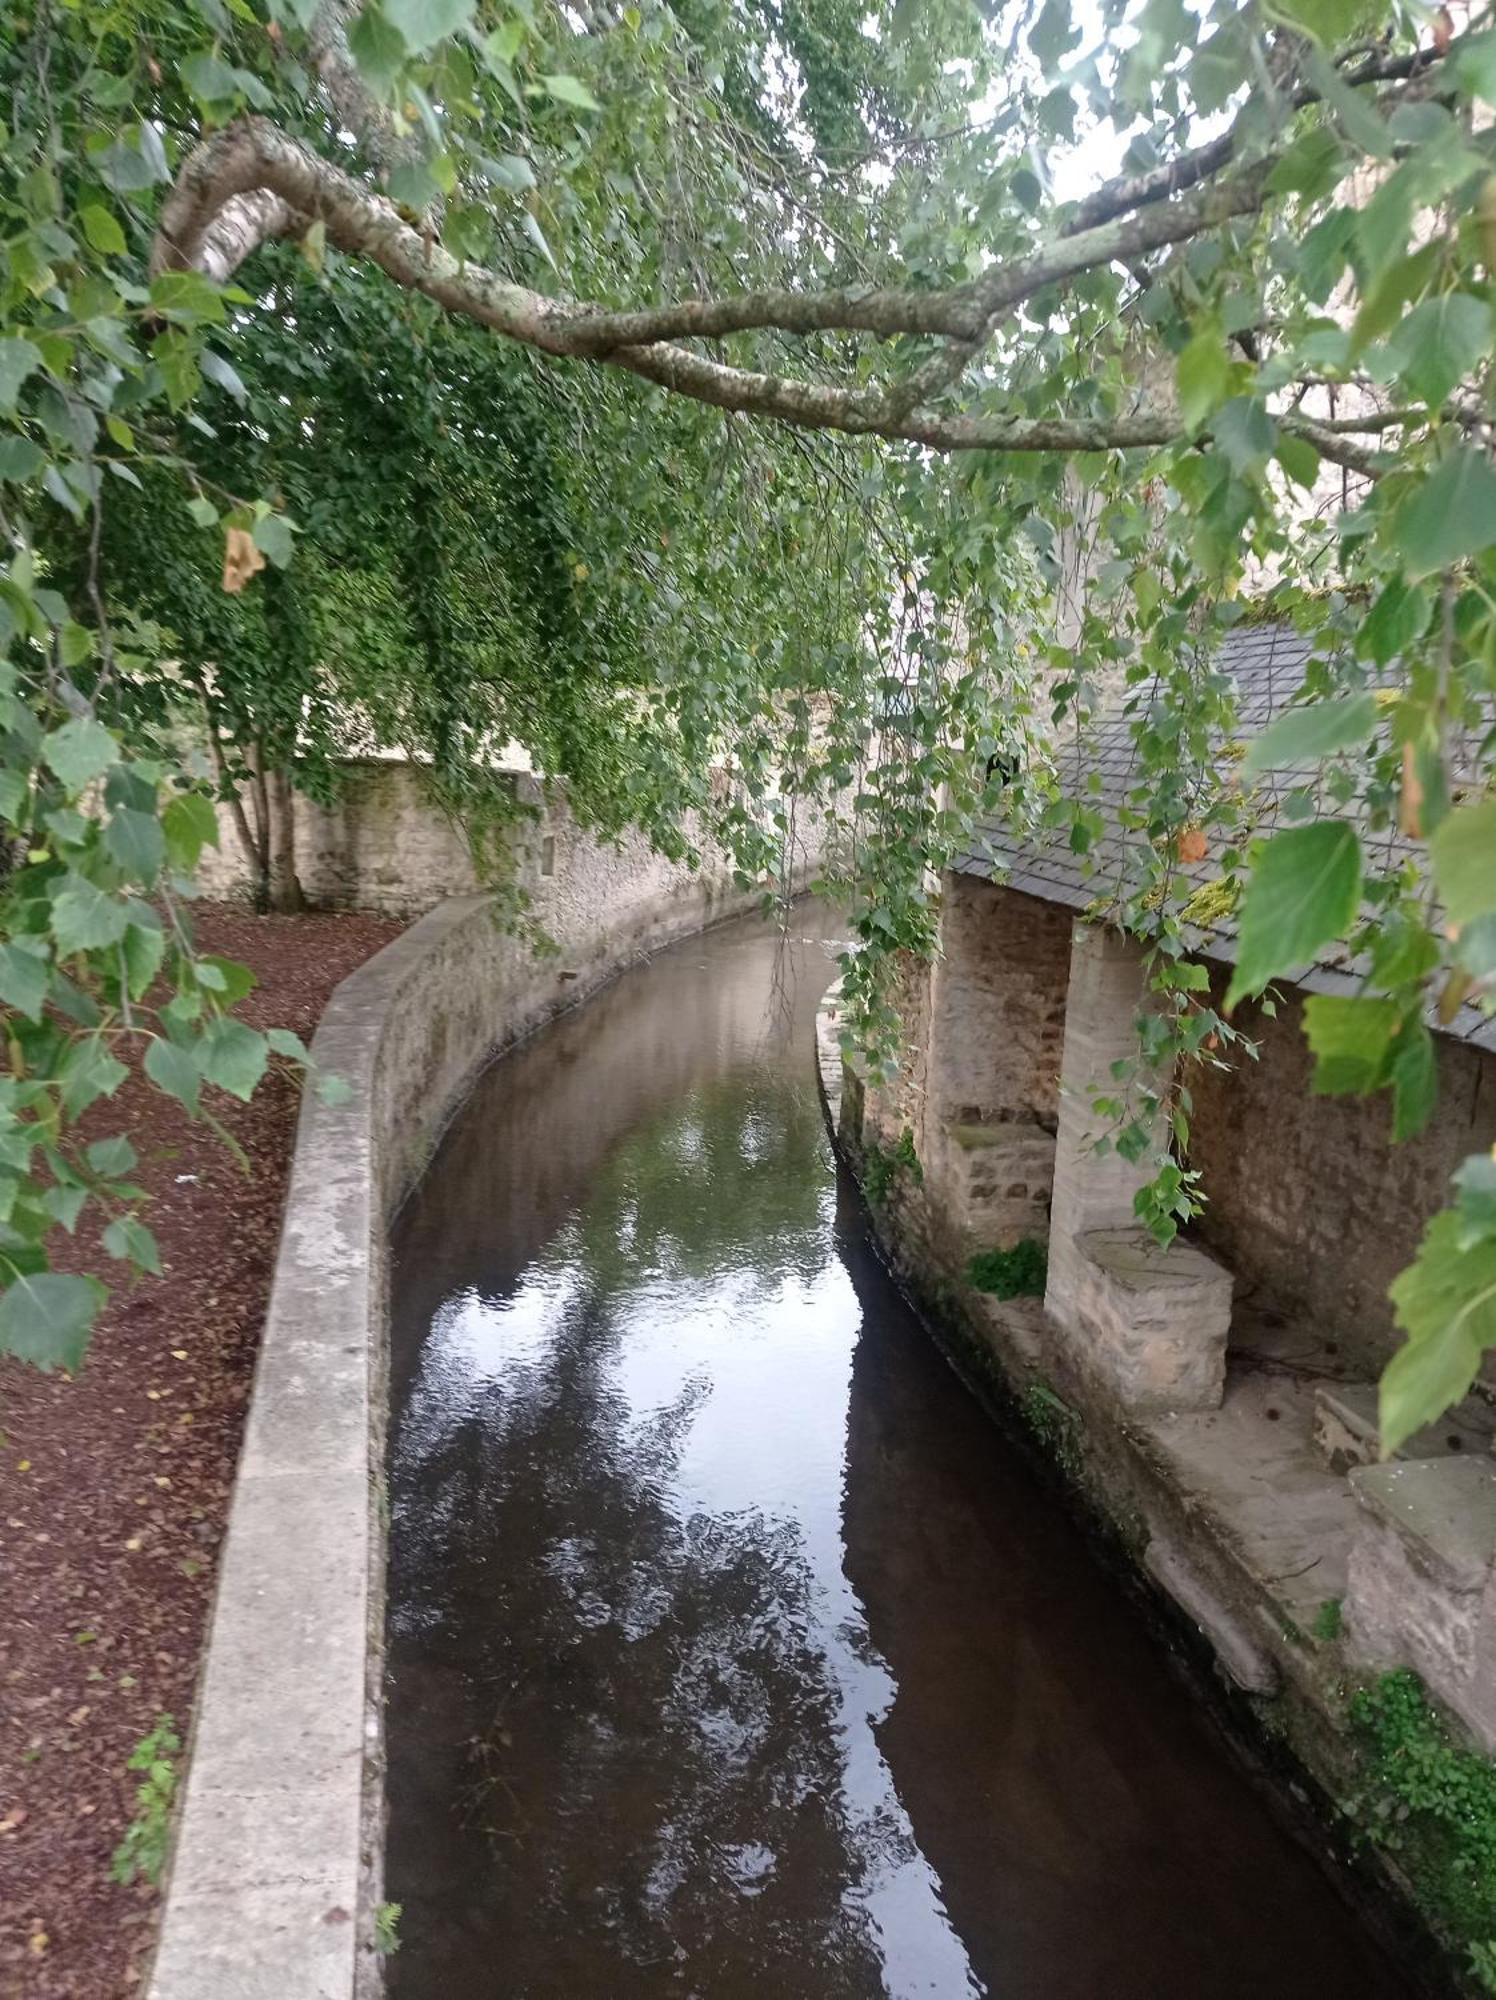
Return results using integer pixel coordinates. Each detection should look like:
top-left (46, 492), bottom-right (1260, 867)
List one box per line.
top-left (1346, 1668), bottom-right (1496, 1994)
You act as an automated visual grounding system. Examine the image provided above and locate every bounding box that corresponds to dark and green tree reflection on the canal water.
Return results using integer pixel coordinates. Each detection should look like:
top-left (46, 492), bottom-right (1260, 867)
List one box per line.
top-left (390, 1074), bottom-right (900, 2000)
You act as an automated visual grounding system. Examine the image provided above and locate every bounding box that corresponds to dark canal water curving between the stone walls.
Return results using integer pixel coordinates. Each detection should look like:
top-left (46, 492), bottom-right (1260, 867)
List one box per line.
top-left (386, 906), bottom-right (1404, 2000)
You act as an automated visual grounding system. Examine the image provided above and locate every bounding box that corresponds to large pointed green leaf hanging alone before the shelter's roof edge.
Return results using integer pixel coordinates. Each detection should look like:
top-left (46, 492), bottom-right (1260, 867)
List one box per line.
top-left (1226, 820), bottom-right (1362, 1008)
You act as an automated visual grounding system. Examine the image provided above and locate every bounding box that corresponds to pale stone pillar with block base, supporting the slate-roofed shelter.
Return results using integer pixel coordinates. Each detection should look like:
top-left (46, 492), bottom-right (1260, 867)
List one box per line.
top-left (1044, 924), bottom-right (1232, 1410)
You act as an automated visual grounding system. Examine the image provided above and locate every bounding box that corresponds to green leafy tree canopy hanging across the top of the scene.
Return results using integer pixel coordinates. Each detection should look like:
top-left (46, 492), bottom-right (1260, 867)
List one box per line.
top-left (0, 0), bottom-right (1496, 1446)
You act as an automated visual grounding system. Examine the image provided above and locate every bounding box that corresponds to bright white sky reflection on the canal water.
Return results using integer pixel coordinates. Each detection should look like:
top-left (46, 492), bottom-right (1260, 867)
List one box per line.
top-left (396, 1136), bottom-right (984, 2000)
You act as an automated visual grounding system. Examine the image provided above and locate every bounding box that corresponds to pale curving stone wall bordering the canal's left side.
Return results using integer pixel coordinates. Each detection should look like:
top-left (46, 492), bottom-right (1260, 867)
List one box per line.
top-left (148, 850), bottom-right (784, 2000)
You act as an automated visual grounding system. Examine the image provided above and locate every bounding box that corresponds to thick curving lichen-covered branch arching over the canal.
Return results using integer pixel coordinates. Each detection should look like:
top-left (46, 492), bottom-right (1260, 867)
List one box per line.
top-left (152, 118), bottom-right (1376, 472)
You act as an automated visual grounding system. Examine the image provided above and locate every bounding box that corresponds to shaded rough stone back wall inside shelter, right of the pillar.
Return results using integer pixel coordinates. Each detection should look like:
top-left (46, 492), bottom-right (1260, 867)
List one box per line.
top-left (1186, 976), bottom-right (1496, 1374)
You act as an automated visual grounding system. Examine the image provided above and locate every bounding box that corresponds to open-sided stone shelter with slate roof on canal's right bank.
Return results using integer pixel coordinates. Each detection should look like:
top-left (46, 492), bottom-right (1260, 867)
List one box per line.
top-left (840, 626), bottom-right (1496, 1788)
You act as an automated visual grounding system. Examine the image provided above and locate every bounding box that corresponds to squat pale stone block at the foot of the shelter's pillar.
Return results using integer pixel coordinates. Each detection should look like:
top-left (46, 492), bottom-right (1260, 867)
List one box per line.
top-left (1048, 1228), bottom-right (1232, 1410)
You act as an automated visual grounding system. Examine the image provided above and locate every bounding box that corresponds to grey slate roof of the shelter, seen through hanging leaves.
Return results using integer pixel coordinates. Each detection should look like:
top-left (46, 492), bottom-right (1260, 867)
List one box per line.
top-left (956, 624), bottom-right (1496, 1052)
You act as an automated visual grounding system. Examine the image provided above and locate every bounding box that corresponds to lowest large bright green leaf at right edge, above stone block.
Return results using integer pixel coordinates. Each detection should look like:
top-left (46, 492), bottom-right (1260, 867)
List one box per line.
top-left (1380, 1208), bottom-right (1496, 1458)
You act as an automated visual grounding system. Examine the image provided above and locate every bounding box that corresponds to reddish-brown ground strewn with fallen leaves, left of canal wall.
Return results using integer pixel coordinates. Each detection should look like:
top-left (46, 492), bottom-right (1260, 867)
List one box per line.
top-left (0, 904), bottom-right (400, 2000)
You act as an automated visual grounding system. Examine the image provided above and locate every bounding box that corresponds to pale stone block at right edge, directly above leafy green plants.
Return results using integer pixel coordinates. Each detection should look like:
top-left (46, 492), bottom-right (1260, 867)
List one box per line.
top-left (1346, 1456), bottom-right (1496, 1750)
